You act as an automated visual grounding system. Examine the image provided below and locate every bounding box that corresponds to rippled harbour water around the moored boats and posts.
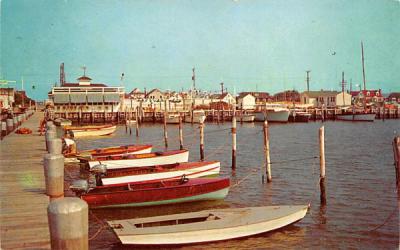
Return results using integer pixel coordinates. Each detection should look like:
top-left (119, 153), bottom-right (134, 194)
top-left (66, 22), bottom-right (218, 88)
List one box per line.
top-left (67, 120), bottom-right (400, 249)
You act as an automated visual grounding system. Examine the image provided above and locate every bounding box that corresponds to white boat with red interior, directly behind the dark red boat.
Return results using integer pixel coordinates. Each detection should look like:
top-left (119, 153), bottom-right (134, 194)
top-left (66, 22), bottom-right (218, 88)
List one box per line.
top-left (91, 161), bottom-right (220, 185)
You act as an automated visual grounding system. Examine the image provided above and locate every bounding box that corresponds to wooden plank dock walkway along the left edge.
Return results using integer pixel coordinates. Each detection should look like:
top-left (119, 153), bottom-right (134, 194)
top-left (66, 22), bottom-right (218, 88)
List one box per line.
top-left (0, 112), bottom-right (50, 249)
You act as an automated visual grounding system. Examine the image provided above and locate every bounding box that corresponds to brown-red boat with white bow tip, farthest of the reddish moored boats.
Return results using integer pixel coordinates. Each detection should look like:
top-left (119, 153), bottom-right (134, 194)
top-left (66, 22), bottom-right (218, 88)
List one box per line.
top-left (65, 145), bottom-right (152, 159)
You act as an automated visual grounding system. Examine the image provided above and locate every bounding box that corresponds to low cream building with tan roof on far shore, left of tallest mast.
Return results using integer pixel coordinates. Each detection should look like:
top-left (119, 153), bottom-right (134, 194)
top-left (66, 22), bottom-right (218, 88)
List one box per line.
top-left (300, 90), bottom-right (351, 108)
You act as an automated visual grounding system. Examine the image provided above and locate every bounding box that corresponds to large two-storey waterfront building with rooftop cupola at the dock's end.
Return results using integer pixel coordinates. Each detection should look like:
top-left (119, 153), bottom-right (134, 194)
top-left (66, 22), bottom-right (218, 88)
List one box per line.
top-left (49, 75), bottom-right (125, 113)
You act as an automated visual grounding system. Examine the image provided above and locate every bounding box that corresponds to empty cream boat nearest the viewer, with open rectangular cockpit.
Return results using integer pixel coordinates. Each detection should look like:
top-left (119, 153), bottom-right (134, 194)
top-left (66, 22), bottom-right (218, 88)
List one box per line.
top-left (107, 205), bottom-right (308, 245)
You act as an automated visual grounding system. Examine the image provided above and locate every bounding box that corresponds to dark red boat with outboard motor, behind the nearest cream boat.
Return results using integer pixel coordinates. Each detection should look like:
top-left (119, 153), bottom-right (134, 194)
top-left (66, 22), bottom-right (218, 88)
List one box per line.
top-left (70, 176), bottom-right (229, 208)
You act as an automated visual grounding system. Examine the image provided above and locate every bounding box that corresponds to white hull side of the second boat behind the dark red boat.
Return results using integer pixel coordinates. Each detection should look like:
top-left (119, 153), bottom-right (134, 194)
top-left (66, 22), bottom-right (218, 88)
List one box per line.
top-left (88, 150), bottom-right (189, 169)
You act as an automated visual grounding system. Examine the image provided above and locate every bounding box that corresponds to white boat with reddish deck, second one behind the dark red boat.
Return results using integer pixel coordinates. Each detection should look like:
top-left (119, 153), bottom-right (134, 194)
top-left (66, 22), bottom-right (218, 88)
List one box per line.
top-left (85, 149), bottom-right (189, 169)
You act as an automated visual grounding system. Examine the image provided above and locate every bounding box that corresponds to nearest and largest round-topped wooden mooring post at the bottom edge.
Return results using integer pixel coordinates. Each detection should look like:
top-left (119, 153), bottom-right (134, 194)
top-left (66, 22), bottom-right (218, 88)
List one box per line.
top-left (47, 197), bottom-right (89, 250)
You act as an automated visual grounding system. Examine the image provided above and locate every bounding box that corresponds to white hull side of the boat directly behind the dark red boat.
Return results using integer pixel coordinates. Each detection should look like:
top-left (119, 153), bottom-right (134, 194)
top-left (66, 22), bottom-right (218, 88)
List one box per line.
top-left (101, 162), bottom-right (220, 185)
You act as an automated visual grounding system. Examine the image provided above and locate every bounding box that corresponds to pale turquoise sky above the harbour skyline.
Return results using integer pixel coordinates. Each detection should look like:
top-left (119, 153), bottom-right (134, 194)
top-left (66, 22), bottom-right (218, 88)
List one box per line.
top-left (0, 0), bottom-right (400, 99)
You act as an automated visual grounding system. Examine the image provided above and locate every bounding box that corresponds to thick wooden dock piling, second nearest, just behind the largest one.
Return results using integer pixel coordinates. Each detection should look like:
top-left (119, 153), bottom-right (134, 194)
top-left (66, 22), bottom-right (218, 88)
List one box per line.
top-left (43, 154), bottom-right (64, 200)
